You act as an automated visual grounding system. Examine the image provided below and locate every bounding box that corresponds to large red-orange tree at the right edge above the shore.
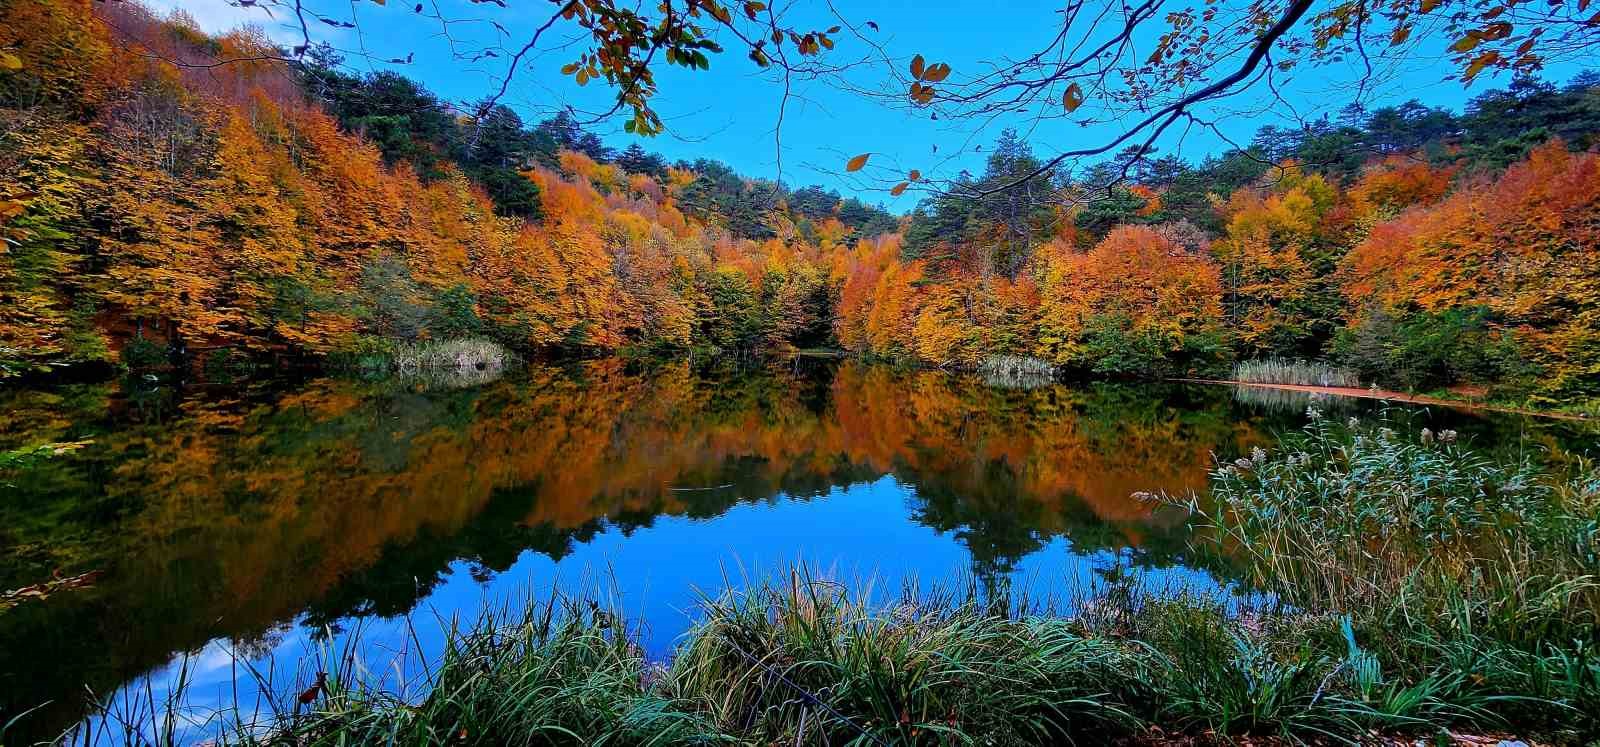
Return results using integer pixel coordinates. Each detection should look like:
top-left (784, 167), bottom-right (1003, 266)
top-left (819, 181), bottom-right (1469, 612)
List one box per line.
top-left (1344, 141), bottom-right (1600, 398)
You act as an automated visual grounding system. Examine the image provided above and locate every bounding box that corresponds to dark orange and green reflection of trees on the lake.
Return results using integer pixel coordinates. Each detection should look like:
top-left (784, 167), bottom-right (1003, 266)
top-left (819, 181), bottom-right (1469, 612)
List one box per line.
top-left (0, 360), bottom-right (1420, 735)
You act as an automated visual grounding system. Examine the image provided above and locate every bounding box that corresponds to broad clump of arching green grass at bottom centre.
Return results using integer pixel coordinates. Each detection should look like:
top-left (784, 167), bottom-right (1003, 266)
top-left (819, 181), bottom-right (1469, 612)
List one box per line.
top-left (664, 574), bottom-right (1152, 744)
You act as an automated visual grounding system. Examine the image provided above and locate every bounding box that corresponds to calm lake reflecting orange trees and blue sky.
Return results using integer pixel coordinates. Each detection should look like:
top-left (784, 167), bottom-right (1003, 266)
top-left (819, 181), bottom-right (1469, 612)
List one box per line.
top-left (0, 358), bottom-right (1597, 739)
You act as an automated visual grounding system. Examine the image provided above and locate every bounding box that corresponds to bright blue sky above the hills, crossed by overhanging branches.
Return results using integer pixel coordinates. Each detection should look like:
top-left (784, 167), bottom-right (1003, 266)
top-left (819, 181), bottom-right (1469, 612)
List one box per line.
top-left (144, 0), bottom-right (1595, 198)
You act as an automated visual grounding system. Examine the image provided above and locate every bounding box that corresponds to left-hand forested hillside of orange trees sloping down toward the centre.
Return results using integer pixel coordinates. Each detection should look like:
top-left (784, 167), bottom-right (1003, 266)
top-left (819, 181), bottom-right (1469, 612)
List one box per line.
top-left (0, 0), bottom-right (898, 371)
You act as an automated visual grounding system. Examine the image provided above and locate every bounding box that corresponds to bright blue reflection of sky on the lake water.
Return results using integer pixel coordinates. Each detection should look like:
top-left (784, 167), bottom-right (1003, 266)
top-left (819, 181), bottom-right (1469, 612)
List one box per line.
top-left (128, 477), bottom-right (1216, 737)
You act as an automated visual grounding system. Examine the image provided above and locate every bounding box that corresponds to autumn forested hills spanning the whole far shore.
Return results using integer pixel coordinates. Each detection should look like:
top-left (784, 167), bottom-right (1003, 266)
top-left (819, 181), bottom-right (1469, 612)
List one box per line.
top-left (0, 0), bottom-right (1600, 405)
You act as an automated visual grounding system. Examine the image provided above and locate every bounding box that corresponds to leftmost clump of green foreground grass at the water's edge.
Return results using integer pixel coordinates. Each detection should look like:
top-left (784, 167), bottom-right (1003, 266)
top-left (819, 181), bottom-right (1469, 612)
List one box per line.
top-left (131, 597), bottom-right (717, 745)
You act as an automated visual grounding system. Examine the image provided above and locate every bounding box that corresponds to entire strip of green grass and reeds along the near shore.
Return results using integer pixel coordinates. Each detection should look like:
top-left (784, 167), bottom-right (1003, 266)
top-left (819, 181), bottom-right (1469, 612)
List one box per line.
top-left (34, 417), bottom-right (1600, 745)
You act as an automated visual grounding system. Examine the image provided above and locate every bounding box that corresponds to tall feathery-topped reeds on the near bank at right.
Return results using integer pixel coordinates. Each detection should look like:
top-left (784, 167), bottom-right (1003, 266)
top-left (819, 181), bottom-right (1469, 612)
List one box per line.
top-left (1165, 411), bottom-right (1600, 739)
